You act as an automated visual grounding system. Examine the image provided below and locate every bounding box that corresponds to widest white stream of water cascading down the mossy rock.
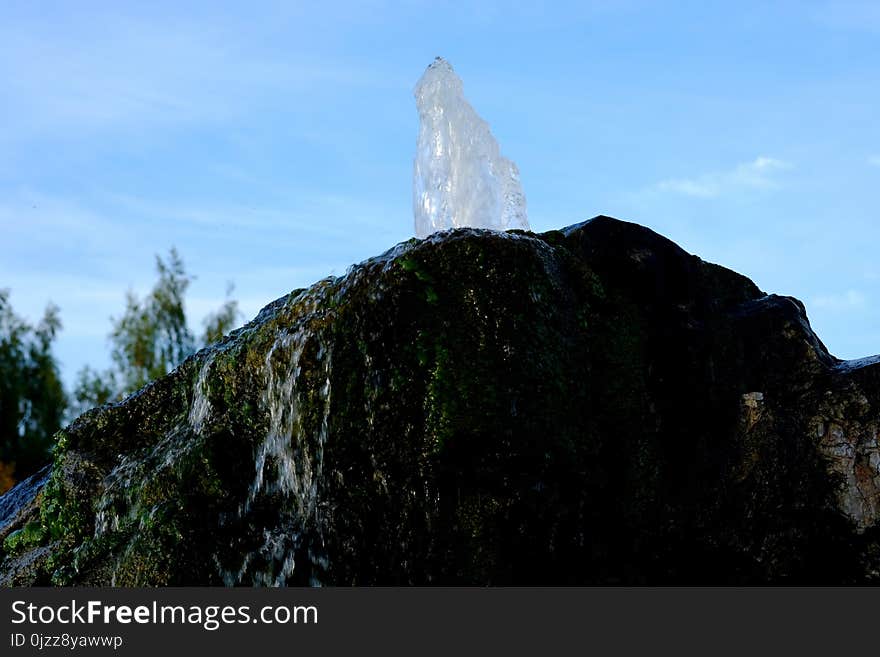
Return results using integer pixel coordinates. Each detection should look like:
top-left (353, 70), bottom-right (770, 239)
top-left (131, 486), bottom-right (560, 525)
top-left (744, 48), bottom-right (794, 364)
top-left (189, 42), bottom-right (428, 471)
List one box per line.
top-left (220, 280), bottom-right (332, 586)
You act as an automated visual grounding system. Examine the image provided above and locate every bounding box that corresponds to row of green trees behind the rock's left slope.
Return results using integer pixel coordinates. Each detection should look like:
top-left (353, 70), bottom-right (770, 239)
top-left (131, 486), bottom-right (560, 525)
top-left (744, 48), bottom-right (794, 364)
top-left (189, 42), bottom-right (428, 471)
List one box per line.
top-left (0, 249), bottom-right (241, 493)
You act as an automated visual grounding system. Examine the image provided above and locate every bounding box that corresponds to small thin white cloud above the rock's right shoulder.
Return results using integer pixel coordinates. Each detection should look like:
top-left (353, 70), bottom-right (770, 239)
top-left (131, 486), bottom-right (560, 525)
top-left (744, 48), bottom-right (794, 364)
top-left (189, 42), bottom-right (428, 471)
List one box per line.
top-left (652, 156), bottom-right (792, 198)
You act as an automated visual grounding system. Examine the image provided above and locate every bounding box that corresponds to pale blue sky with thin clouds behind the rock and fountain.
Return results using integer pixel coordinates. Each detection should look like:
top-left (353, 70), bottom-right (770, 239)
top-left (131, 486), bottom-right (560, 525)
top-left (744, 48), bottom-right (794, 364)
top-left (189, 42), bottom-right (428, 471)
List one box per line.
top-left (0, 0), bottom-right (880, 381)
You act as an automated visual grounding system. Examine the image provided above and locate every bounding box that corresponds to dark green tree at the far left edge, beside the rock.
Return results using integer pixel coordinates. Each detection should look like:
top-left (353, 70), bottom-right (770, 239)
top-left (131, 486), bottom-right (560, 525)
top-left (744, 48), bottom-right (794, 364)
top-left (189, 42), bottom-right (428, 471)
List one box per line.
top-left (0, 290), bottom-right (67, 492)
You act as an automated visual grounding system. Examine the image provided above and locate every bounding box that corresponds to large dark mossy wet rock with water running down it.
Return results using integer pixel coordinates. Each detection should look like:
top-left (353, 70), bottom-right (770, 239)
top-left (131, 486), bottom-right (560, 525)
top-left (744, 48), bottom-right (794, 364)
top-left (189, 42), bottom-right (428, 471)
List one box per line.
top-left (0, 217), bottom-right (880, 585)
